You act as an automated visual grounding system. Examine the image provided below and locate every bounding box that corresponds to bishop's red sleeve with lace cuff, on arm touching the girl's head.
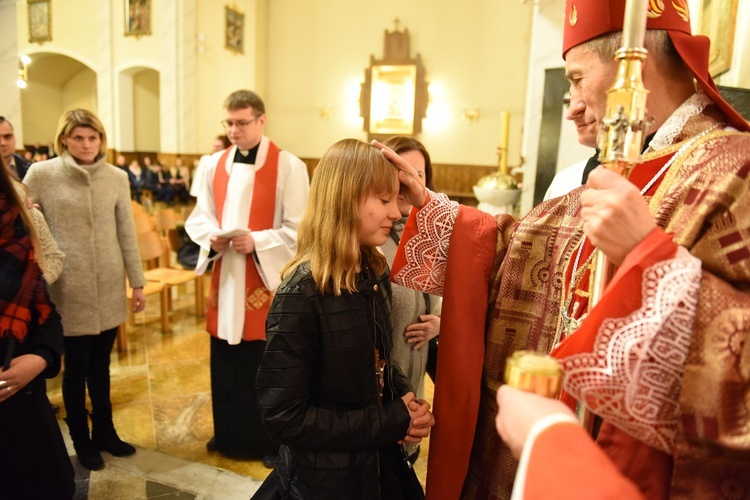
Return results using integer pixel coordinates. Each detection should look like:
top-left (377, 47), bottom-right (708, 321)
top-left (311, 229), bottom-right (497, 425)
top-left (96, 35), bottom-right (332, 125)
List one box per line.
top-left (391, 192), bottom-right (510, 499)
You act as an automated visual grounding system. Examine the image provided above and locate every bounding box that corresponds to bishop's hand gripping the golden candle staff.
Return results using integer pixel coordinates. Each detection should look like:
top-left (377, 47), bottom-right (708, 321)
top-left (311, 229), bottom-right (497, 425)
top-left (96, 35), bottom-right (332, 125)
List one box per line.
top-left (581, 168), bottom-right (656, 266)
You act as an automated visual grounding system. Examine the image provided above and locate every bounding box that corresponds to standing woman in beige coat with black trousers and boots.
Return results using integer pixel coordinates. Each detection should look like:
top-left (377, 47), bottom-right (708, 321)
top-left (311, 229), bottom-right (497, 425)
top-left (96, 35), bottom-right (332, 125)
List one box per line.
top-left (24, 109), bottom-right (146, 470)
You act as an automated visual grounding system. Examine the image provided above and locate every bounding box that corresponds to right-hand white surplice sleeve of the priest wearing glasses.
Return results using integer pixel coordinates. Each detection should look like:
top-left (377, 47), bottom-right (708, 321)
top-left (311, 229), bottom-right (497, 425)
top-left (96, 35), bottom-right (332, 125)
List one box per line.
top-left (253, 151), bottom-right (310, 291)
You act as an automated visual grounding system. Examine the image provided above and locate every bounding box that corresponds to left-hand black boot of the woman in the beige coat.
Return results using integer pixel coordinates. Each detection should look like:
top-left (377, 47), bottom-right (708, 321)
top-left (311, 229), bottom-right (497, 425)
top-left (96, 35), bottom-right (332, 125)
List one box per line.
top-left (62, 375), bottom-right (104, 470)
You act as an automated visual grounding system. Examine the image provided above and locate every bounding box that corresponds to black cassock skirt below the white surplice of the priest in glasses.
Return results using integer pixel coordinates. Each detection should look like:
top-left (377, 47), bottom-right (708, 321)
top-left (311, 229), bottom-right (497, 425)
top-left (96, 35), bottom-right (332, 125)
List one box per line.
top-left (211, 337), bottom-right (279, 458)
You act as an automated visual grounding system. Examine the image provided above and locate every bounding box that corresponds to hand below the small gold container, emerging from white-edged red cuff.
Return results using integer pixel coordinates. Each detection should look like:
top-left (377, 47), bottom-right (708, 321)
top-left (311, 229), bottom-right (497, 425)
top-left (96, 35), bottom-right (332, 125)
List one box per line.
top-left (495, 385), bottom-right (575, 458)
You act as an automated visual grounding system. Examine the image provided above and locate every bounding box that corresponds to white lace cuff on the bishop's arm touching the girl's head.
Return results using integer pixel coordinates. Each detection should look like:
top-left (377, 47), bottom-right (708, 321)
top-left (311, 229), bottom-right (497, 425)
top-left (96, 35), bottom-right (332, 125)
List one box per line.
top-left (393, 192), bottom-right (458, 296)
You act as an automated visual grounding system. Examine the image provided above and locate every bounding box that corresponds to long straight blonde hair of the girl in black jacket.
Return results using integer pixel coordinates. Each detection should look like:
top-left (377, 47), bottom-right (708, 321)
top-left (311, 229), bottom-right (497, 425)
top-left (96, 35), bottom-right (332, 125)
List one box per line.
top-left (281, 139), bottom-right (397, 295)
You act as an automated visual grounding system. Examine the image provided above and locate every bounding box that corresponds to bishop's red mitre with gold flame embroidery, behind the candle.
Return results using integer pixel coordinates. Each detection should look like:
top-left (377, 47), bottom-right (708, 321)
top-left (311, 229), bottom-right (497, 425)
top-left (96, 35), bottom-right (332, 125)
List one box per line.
top-left (563, 0), bottom-right (750, 131)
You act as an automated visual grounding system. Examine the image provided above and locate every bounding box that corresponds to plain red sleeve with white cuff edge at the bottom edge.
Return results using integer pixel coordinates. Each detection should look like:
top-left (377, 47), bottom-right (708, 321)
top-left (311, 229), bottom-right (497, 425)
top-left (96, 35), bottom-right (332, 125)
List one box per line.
top-left (511, 415), bottom-right (644, 500)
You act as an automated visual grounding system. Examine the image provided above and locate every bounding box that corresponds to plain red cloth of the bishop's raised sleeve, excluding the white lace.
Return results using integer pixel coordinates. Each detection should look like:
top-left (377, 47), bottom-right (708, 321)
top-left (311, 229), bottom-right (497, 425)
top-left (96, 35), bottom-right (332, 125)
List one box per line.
top-left (391, 199), bottom-right (498, 499)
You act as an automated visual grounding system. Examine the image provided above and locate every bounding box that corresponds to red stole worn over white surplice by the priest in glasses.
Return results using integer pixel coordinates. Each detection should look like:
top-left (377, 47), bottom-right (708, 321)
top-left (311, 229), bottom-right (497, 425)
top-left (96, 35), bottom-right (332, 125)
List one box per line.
top-left (206, 142), bottom-right (280, 341)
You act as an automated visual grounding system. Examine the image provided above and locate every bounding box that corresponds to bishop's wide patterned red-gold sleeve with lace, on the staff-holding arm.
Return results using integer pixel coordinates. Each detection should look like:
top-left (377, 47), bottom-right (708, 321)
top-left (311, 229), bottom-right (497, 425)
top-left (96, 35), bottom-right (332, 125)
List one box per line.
top-left (553, 141), bottom-right (750, 464)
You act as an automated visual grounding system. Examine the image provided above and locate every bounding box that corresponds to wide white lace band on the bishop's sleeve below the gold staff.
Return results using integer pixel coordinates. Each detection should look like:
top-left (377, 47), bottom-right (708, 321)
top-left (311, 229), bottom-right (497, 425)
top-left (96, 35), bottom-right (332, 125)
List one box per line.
top-left (562, 247), bottom-right (701, 453)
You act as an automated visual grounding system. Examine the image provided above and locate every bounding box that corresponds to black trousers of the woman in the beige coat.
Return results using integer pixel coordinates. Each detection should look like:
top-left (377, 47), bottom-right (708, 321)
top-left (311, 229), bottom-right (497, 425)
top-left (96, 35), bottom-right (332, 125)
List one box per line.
top-left (62, 328), bottom-right (117, 425)
